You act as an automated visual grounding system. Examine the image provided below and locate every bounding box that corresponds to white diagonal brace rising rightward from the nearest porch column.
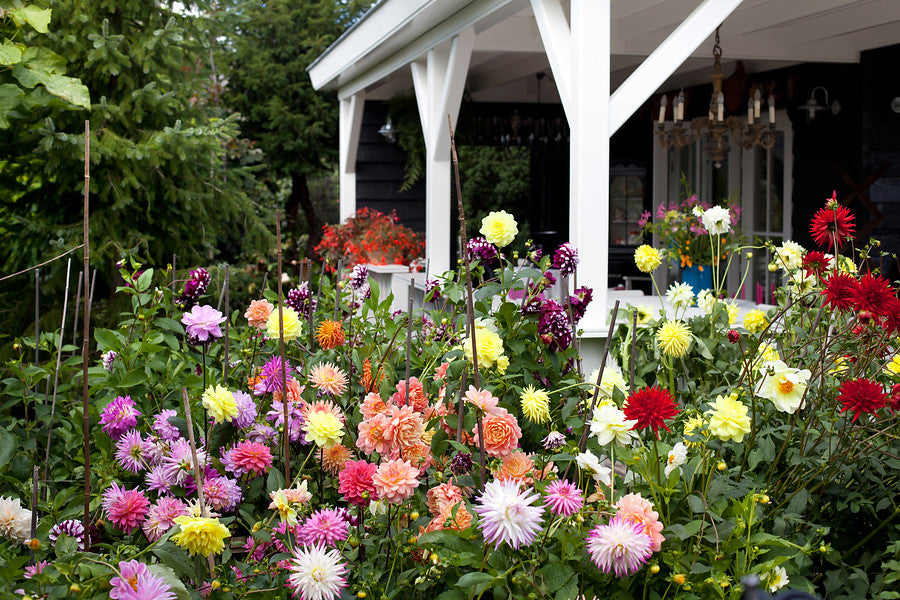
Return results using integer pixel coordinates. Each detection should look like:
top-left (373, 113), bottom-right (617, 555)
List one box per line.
top-left (604, 0), bottom-right (743, 134)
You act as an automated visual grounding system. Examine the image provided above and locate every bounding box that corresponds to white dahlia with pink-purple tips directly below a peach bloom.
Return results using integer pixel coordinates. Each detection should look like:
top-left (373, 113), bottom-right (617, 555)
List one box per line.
top-left (586, 516), bottom-right (653, 577)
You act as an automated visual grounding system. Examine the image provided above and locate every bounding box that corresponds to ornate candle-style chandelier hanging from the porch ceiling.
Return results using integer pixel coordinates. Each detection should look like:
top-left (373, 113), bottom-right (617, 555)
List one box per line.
top-left (656, 27), bottom-right (777, 169)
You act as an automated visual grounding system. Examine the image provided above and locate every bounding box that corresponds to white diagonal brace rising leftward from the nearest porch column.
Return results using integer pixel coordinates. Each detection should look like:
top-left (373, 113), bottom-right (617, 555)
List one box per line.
top-left (531, 0), bottom-right (572, 119)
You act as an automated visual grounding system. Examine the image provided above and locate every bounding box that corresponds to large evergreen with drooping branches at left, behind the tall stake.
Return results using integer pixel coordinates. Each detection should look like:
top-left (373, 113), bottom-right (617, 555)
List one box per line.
top-left (0, 0), bottom-right (271, 272)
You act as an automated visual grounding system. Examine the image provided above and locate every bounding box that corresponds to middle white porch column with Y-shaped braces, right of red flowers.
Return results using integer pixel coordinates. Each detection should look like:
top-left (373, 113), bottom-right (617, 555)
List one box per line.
top-left (410, 27), bottom-right (475, 274)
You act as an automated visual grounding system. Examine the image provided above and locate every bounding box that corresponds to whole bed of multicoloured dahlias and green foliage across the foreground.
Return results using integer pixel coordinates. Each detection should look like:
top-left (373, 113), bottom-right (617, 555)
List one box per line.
top-left (0, 203), bottom-right (900, 600)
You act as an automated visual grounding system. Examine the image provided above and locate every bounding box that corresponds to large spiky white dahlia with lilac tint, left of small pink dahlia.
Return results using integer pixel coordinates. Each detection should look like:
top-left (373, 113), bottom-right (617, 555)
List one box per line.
top-left (474, 480), bottom-right (544, 550)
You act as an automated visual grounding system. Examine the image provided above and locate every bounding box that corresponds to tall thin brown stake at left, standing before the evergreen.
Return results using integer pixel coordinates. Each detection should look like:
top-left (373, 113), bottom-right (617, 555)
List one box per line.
top-left (81, 120), bottom-right (92, 548)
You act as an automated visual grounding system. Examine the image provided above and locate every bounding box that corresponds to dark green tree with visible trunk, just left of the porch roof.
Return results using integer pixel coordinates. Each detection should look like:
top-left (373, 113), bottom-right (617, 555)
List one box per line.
top-left (225, 0), bottom-right (372, 260)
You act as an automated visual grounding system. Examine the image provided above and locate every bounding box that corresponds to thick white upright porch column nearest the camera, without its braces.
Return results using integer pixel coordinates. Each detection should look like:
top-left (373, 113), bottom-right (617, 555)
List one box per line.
top-left (567, 0), bottom-right (611, 337)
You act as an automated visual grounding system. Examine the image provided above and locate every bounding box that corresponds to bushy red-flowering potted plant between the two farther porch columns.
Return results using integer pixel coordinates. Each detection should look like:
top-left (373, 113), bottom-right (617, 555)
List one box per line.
top-left (315, 207), bottom-right (425, 271)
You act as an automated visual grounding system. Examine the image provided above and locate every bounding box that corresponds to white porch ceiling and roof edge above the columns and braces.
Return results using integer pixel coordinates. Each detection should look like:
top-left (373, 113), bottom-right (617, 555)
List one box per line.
top-left (309, 0), bottom-right (900, 102)
